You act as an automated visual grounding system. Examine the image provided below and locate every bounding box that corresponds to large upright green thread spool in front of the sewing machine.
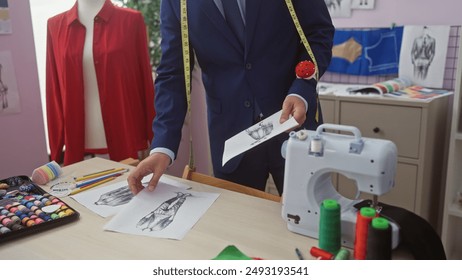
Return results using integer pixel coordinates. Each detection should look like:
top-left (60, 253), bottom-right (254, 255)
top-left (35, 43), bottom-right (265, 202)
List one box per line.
top-left (319, 199), bottom-right (342, 255)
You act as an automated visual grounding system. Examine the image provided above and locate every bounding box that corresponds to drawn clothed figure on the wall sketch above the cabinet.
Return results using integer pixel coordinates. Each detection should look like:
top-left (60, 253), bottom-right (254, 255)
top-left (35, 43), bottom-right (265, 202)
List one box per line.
top-left (411, 26), bottom-right (436, 80)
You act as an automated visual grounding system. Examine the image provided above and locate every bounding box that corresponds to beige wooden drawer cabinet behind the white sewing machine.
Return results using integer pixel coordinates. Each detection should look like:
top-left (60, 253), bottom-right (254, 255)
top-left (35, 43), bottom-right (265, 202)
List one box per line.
top-left (320, 95), bottom-right (452, 230)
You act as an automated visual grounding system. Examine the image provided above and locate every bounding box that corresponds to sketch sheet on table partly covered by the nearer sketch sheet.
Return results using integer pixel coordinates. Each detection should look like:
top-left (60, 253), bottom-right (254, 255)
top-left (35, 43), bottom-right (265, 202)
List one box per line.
top-left (71, 174), bottom-right (189, 218)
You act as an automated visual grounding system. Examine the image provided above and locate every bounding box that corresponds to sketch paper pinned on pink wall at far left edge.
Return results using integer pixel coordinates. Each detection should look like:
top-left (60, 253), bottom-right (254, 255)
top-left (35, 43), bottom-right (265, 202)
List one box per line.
top-left (0, 51), bottom-right (21, 115)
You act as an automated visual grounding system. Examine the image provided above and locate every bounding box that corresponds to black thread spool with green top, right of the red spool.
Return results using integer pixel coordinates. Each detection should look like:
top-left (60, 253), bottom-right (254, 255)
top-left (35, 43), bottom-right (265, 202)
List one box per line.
top-left (366, 217), bottom-right (391, 260)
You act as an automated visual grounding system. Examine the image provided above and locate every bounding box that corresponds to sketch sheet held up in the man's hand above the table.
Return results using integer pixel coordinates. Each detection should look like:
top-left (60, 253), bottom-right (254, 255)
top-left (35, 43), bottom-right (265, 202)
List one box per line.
top-left (222, 110), bottom-right (298, 165)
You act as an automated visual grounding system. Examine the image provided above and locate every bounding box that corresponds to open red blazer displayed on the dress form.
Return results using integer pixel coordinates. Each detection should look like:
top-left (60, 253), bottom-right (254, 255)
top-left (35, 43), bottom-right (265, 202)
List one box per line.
top-left (46, 0), bottom-right (155, 165)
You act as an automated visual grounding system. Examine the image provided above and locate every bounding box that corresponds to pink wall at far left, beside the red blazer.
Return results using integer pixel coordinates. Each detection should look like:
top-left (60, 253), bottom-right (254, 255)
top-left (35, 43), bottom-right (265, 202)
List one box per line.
top-left (0, 0), bottom-right (48, 179)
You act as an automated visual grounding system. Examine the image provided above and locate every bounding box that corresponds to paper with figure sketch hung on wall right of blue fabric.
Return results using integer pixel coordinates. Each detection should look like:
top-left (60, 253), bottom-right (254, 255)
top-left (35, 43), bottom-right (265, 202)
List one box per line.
top-left (399, 25), bottom-right (450, 88)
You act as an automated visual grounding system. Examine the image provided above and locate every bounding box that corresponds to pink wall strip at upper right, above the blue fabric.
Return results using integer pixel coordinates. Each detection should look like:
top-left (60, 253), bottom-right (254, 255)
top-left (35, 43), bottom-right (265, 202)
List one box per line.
top-left (333, 0), bottom-right (462, 27)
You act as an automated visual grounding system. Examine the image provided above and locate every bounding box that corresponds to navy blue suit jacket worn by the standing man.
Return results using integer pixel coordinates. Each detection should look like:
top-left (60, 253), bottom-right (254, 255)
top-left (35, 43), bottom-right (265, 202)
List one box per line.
top-left (151, 0), bottom-right (334, 173)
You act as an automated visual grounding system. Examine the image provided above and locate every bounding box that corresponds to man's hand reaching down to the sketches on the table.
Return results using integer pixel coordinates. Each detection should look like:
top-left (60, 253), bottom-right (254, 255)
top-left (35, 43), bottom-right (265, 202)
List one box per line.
top-left (127, 153), bottom-right (170, 195)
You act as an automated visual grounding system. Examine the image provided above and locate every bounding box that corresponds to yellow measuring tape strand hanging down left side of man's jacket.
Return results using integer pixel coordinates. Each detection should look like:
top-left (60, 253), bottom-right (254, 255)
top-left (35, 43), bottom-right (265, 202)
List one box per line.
top-left (180, 0), bottom-right (195, 169)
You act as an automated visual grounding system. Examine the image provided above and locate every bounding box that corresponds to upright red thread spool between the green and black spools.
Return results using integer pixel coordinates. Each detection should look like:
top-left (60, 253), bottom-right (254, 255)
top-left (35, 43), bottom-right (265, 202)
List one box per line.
top-left (353, 207), bottom-right (377, 260)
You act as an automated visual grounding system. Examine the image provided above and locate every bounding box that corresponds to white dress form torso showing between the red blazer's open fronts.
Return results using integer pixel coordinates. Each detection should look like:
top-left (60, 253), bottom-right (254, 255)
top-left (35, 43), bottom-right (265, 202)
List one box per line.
top-left (77, 0), bottom-right (107, 149)
